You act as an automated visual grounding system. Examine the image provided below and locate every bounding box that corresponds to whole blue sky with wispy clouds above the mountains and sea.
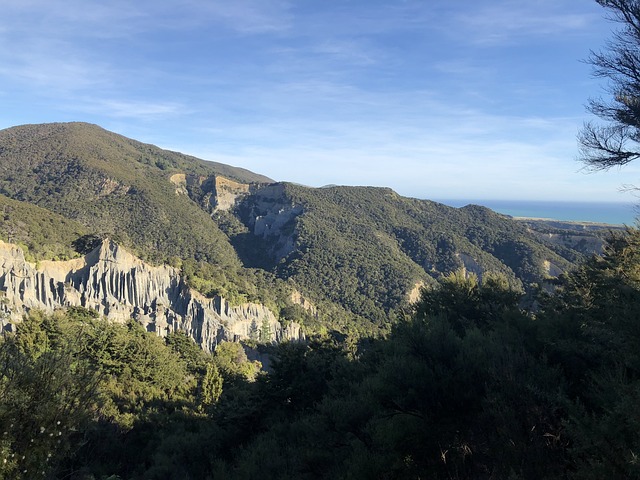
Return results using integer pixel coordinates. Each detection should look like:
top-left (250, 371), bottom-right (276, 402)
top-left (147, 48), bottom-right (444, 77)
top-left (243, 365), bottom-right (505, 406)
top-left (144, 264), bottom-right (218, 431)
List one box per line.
top-left (0, 0), bottom-right (640, 201)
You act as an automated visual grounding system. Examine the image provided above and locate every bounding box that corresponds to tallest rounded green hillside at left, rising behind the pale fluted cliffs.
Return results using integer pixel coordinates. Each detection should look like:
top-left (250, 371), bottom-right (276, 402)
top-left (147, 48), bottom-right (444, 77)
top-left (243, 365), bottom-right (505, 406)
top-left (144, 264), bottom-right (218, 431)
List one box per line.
top-left (0, 123), bottom-right (269, 265)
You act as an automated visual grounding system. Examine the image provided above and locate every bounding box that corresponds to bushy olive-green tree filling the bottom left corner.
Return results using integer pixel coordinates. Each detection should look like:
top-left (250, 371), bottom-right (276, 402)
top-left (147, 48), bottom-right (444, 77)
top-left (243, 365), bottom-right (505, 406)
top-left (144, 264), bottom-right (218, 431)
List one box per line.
top-left (0, 311), bottom-right (101, 479)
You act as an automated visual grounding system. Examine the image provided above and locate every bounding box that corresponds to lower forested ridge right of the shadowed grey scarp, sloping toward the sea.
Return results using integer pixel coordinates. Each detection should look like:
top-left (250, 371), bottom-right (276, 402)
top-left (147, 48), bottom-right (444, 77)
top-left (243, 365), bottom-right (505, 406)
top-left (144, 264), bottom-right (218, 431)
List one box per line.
top-left (229, 184), bottom-right (582, 322)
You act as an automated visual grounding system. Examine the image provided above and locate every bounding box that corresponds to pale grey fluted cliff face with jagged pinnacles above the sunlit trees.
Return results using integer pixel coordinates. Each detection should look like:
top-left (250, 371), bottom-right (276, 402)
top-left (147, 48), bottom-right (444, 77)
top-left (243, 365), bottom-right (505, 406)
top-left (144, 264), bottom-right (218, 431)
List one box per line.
top-left (0, 240), bottom-right (304, 351)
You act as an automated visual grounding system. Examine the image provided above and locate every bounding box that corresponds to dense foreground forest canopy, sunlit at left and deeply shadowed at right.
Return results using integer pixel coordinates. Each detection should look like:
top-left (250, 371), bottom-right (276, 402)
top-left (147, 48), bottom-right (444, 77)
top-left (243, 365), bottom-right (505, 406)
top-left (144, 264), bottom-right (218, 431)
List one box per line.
top-left (0, 230), bottom-right (640, 479)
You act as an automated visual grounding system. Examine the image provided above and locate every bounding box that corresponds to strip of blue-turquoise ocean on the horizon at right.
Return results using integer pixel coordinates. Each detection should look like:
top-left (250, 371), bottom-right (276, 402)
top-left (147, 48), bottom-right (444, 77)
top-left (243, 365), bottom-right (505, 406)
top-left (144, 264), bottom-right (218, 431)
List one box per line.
top-left (434, 199), bottom-right (640, 226)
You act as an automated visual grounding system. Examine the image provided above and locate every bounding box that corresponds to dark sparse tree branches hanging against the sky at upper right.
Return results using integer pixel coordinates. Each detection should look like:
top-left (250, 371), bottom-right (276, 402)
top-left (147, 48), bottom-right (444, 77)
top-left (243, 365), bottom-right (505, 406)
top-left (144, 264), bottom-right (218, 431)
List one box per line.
top-left (578, 0), bottom-right (640, 170)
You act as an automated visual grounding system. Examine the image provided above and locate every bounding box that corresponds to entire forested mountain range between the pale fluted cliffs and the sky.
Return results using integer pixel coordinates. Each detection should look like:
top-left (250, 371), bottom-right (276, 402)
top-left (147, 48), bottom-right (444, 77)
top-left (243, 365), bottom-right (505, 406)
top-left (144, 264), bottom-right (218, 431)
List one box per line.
top-left (0, 123), bottom-right (601, 332)
